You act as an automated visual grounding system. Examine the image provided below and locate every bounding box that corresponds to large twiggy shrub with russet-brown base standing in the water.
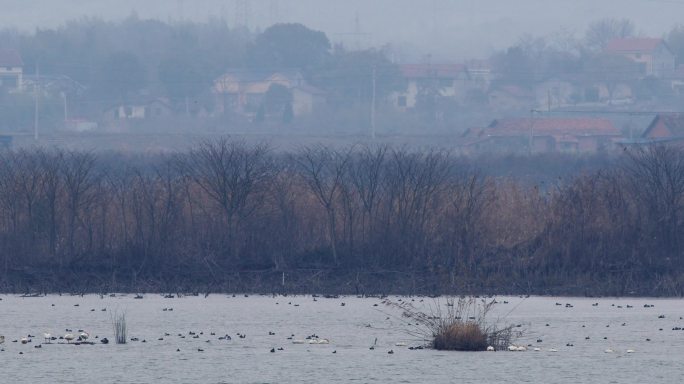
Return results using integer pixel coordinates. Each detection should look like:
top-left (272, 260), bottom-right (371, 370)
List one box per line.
top-left (385, 297), bottom-right (520, 351)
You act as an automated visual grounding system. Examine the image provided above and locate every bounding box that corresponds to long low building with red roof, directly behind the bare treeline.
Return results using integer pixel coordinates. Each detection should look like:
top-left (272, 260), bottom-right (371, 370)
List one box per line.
top-left (463, 117), bottom-right (622, 153)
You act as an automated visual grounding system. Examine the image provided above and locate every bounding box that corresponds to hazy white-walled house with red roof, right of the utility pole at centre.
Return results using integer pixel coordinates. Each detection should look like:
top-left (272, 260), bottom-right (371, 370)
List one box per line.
top-left (390, 64), bottom-right (470, 110)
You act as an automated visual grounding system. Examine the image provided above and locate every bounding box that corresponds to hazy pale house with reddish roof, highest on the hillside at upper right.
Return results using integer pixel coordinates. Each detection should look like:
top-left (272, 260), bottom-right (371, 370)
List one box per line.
top-left (606, 37), bottom-right (675, 78)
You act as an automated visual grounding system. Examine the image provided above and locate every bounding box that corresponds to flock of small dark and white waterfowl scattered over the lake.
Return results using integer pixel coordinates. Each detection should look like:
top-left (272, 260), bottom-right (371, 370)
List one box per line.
top-left (0, 295), bottom-right (684, 354)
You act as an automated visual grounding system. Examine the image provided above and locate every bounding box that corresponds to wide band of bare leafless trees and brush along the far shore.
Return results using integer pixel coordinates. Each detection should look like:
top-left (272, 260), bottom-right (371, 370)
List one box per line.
top-left (0, 139), bottom-right (684, 294)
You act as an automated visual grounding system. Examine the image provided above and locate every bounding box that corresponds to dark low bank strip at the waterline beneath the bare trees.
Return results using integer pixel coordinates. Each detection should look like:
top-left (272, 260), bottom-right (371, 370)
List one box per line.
top-left (0, 268), bottom-right (684, 297)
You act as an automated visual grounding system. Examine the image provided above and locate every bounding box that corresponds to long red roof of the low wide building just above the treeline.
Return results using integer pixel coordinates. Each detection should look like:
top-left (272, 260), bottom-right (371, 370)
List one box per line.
top-left (485, 117), bottom-right (620, 137)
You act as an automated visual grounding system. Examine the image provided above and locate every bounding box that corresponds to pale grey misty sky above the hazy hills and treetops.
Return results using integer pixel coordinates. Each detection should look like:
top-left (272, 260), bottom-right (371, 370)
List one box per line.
top-left (0, 0), bottom-right (684, 61)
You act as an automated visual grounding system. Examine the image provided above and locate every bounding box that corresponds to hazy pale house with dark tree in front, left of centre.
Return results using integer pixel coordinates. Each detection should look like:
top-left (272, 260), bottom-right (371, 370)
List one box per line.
top-left (212, 69), bottom-right (325, 117)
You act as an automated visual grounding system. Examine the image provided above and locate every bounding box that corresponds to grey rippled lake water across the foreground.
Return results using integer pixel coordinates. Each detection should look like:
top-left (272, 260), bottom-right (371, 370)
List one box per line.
top-left (0, 294), bottom-right (684, 384)
